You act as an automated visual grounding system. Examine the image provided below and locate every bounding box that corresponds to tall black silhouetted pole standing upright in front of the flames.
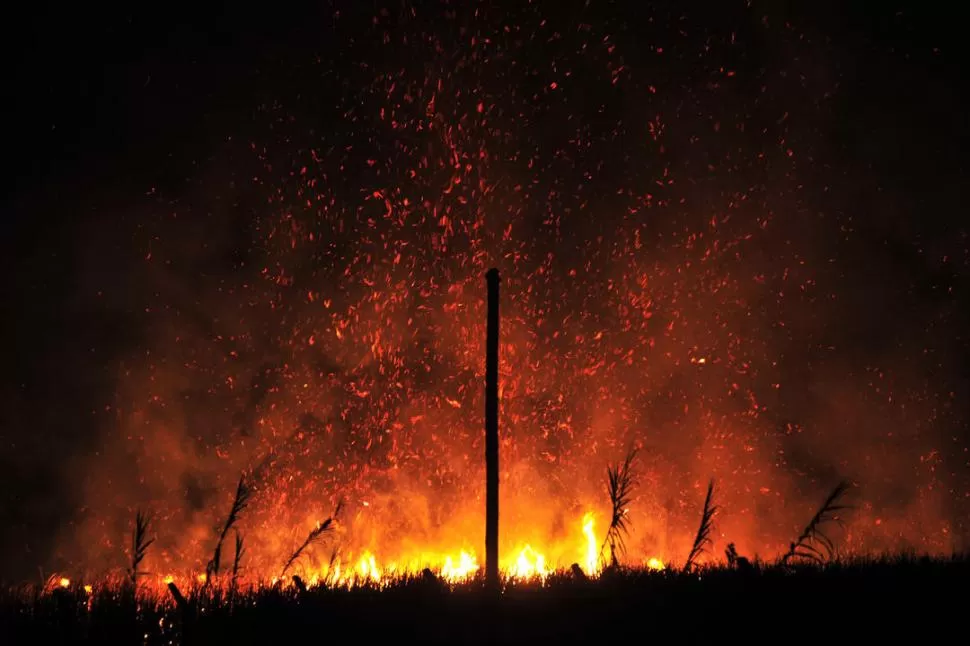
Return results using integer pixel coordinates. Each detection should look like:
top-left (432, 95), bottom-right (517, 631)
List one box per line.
top-left (485, 269), bottom-right (499, 590)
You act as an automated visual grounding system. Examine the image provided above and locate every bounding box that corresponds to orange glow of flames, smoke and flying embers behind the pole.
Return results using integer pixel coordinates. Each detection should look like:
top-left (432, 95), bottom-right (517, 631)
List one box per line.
top-left (47, 5), bottom-right (965, 578)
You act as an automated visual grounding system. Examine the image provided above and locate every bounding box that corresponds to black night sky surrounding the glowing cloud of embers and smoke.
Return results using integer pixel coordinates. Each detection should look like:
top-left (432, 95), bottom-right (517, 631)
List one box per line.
top-left (0, 0), bottom-right (970, 588)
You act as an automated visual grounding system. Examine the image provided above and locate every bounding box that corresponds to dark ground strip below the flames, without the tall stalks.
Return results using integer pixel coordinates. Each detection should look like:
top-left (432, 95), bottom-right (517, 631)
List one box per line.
top-left (0, 555), bottom-right (970, 645)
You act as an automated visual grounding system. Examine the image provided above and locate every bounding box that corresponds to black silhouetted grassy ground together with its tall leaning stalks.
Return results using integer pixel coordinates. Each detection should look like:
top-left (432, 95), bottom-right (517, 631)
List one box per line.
top-left (0, 464), bottom-right (932, 646)
